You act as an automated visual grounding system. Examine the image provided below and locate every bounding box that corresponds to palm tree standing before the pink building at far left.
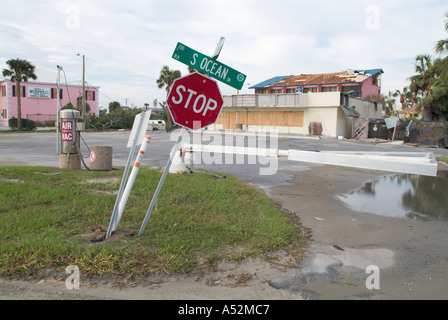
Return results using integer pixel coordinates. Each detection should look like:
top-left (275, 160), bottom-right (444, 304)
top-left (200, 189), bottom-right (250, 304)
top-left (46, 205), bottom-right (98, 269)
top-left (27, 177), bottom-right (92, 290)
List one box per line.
top-left (3, 59), bottom-right (37, 131)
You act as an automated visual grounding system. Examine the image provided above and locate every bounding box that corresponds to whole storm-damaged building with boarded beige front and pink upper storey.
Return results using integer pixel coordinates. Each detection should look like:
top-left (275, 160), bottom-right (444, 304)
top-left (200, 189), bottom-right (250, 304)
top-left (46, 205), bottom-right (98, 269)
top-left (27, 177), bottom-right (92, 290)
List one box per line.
top-left (211, 69), bottom-right (383, 138)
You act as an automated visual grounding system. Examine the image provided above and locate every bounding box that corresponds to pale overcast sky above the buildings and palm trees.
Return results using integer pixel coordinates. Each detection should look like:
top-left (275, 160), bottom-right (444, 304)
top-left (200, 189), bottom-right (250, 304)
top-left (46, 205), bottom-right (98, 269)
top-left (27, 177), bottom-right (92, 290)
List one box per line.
top-left (0, 0), bottom-right (448, 107)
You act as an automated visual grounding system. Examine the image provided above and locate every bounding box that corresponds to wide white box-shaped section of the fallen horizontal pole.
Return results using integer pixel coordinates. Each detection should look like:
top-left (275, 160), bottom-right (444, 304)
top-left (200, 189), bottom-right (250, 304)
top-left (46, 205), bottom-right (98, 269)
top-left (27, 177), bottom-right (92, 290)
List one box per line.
top-left (288, 150), bottom-right (437, 177)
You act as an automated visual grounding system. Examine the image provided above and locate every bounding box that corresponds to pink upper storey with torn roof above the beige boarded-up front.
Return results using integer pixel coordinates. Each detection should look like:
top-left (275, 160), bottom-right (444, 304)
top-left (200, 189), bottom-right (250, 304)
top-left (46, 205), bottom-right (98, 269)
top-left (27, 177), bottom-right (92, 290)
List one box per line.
top-left (250, 69), bottom-right (384, 99)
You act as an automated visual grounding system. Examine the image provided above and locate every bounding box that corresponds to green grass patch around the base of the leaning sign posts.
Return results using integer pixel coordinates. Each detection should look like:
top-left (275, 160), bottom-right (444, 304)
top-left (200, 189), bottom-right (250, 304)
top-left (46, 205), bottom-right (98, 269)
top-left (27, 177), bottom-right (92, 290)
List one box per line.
top-left (0, 166), bottom-right (305, 276)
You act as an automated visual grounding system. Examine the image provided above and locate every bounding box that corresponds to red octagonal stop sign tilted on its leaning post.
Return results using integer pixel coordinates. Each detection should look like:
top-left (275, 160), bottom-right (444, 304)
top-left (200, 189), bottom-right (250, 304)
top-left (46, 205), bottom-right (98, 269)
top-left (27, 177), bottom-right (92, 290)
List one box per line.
top-left (167, 72), bottom-right (224, 130)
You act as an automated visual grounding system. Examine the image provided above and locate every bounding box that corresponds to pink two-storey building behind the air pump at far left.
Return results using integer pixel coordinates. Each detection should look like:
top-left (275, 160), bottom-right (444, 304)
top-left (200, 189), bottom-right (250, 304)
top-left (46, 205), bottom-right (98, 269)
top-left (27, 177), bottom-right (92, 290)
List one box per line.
top-left (0, 80), bottom-right (99, 128)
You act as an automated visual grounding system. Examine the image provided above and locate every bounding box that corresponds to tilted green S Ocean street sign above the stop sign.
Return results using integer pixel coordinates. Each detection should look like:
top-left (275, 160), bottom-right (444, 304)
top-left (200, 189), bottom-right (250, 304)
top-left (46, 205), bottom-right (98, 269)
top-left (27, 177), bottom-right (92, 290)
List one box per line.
top-left (173, 42), bottom-right (246, 90)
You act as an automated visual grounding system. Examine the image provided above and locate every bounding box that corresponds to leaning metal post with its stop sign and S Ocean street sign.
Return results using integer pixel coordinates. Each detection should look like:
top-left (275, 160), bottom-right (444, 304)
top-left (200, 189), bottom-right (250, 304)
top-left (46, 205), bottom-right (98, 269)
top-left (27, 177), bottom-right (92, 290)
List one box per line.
top-left (139, 37), bottom-right (242, 235)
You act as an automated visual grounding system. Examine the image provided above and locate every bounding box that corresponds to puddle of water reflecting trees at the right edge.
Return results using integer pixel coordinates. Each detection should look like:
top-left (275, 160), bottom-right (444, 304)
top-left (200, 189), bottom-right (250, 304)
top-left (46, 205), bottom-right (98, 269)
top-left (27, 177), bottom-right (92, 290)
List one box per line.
top-left (338, 172), bottom-right (448, 221)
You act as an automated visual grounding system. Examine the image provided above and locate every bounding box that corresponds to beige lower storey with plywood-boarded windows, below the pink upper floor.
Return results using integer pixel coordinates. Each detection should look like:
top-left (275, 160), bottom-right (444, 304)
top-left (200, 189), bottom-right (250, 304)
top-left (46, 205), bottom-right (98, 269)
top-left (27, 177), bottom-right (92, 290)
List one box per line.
top-left (209, 92), bottom-right (381, 138)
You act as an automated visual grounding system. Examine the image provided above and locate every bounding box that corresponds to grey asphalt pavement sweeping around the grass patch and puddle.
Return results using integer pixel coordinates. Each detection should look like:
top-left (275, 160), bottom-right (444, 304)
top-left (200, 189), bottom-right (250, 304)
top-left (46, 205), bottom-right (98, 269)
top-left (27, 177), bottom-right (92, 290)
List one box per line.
top-left (0, 130), bottom-right (448, 299)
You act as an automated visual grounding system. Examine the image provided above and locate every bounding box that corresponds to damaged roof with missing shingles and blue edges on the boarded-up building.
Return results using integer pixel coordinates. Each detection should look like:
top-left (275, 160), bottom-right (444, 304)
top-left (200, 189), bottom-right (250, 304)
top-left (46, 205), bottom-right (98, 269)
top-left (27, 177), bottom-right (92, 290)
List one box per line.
top-left (249, 69), bottom-right (384, 89)
